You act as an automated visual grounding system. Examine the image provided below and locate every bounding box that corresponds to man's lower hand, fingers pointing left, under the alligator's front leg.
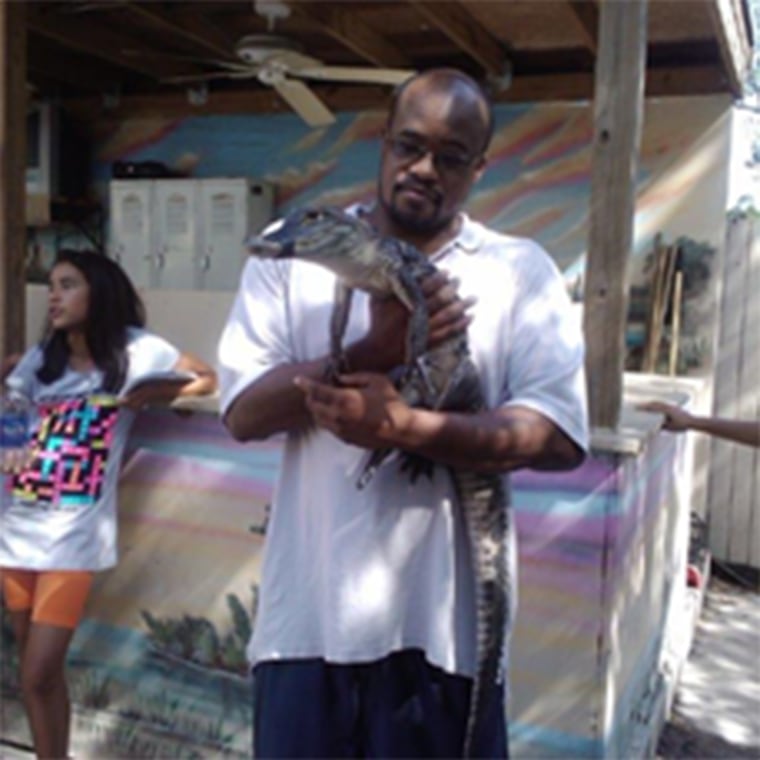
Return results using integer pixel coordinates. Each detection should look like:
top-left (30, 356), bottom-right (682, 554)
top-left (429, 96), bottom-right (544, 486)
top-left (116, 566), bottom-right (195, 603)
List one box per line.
top-left (293, 372), bottom-right (411, 449)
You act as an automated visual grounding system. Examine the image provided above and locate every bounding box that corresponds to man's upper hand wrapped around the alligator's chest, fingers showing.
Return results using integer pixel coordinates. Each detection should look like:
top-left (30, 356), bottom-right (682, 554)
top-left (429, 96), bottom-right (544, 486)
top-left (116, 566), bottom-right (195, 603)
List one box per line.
top-left (349, 271), bottom-right (475, 372)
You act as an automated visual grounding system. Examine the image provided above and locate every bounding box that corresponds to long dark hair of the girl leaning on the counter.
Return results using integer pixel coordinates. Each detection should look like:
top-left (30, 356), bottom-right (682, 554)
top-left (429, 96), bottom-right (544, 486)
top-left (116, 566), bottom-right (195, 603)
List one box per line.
top-left (37, 249), bottom-right (145, 393)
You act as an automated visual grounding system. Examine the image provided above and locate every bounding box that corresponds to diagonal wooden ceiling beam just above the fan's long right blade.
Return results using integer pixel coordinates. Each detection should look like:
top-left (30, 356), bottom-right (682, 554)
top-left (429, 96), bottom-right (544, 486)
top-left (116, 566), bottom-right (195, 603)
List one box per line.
top-left (291, 3), bottom-right (413, 69)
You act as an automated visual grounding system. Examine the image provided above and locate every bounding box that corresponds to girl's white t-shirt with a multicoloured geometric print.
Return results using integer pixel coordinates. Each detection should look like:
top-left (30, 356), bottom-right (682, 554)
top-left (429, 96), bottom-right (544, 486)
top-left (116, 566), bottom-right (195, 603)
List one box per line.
top-left (0, 328), bottom-right (180, 570)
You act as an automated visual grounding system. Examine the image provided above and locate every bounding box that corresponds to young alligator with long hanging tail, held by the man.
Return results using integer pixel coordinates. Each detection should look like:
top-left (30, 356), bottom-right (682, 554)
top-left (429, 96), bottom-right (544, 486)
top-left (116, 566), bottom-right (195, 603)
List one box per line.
top-left (245, 206), bottom-right (511, 757)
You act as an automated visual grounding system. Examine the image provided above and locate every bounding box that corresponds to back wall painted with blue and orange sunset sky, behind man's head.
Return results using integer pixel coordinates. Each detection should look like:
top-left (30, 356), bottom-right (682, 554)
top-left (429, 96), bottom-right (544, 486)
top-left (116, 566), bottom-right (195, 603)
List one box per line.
top-left (70, 96), bottom-right (731, 284)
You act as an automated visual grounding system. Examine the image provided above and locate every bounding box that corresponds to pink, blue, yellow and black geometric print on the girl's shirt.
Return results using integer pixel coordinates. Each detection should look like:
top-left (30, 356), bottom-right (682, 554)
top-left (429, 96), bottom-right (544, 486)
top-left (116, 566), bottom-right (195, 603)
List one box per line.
top-left (11, 394), bottom-right (119, 510)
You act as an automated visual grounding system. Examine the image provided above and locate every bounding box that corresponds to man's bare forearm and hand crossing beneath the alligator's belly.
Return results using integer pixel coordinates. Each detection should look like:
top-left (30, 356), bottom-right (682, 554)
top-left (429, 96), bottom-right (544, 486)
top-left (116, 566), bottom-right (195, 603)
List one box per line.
top-left (295, 373), bottom-right (584, 472)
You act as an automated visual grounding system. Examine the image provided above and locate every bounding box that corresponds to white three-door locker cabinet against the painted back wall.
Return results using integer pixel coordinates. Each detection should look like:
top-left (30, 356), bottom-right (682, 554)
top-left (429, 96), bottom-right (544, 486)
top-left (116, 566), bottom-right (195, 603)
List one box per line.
top-left (110, 177), bottom-right (274, 290)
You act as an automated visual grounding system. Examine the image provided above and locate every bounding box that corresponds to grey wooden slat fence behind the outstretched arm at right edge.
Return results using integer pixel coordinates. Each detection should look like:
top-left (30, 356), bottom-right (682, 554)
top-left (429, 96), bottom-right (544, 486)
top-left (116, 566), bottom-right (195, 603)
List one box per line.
top-left (708, 212), bottom-right (760, 568)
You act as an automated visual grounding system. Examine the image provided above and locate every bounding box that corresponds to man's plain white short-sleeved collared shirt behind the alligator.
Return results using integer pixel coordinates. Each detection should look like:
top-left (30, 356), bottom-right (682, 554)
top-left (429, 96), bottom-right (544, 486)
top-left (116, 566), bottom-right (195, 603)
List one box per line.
top-left (219, 211), bottom-right (588, 676)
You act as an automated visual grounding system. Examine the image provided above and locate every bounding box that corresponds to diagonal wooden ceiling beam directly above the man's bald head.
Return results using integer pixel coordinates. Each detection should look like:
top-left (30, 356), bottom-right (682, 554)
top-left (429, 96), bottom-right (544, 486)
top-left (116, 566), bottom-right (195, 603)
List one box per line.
top-left (407, 0), bottom-right (507, 78)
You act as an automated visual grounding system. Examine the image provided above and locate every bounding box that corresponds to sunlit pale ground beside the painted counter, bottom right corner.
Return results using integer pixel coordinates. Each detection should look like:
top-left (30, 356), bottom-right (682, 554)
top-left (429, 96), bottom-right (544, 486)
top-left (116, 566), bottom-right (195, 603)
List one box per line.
top-left (657, 567), bottom-right (760, 760)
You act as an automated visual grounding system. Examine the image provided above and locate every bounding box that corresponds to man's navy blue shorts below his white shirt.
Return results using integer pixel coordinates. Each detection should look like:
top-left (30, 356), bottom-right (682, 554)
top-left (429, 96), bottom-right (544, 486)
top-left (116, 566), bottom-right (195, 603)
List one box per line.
top-left (253, 650), bottom-right (508, 760)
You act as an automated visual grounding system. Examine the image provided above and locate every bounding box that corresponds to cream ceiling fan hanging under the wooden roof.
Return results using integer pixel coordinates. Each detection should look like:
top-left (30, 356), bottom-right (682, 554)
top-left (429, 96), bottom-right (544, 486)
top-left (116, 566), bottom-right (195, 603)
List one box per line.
top-left (163, 34), bottom-right (414, 127)
